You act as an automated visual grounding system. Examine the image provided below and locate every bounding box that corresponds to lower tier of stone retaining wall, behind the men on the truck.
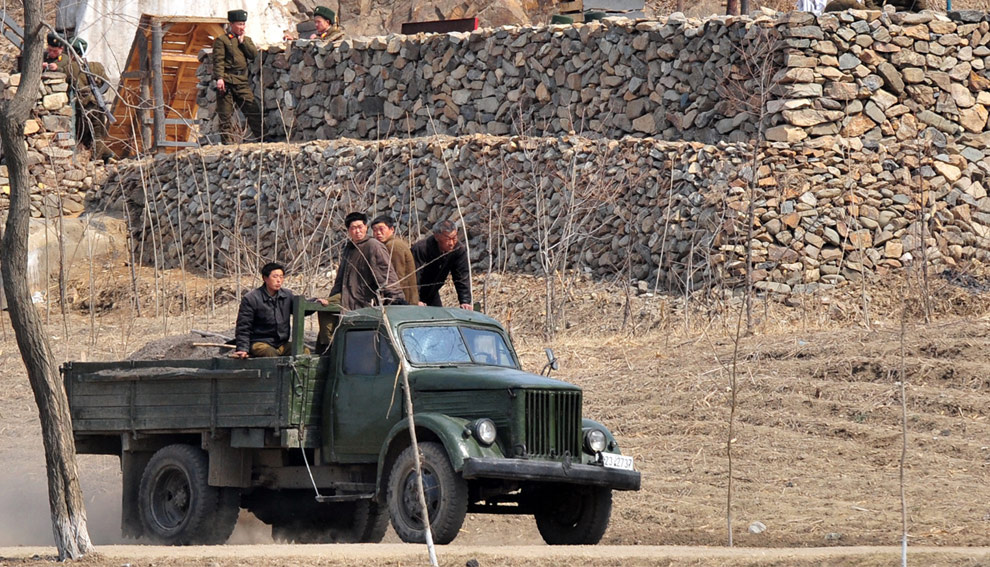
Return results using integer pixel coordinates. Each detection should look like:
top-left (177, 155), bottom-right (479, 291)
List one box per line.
top-left (91, 136), bottom-right (990, 292)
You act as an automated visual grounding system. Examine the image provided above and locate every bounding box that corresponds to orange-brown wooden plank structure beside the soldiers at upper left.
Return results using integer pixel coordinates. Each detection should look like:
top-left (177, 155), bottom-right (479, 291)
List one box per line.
top-left (107, 14), bottom-right (227, 157)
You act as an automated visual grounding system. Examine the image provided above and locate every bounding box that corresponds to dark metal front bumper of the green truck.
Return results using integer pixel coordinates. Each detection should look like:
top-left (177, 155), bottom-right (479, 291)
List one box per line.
top-left (461, 457), bottom-right (640, 490)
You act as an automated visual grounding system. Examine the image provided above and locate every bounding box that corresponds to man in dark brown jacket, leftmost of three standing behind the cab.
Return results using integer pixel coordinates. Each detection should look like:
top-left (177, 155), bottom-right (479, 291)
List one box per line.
top-left (316, 213), bottom-right (406, 354)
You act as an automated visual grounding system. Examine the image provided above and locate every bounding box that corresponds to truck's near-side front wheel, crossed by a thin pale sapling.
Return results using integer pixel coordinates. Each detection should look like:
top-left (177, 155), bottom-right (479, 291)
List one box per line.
top-left (388, 442), bottom-right (468, 545)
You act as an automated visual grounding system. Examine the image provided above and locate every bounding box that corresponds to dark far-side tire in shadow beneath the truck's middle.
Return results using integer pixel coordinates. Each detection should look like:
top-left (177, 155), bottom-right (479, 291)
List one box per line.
top-left (272, 500), bottom-right (388, 543)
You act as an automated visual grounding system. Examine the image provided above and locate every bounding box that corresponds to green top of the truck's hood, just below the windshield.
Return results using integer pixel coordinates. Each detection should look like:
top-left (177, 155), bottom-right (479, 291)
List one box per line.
top-left (409, 364), bottom-right (581, 392)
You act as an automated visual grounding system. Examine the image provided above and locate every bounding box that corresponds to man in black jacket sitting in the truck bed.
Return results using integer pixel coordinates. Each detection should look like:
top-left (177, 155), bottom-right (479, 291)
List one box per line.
top-left (231, 262), bottom-right (327, 358)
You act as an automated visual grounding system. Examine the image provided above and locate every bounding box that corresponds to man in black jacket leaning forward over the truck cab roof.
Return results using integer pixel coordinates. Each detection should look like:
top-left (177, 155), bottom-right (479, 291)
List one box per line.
top-left (412, 221), bottom-right (472, 309)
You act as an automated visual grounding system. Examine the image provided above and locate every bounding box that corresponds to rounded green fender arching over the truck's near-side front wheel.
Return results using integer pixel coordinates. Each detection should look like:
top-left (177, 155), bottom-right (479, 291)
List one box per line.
top-left (378, 413), bottom-right (505, 491)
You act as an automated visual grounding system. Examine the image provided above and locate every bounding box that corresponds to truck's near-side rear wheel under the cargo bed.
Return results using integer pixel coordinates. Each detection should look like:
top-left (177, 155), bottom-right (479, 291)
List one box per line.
top-left (138, 445), bottom-right (240, 545)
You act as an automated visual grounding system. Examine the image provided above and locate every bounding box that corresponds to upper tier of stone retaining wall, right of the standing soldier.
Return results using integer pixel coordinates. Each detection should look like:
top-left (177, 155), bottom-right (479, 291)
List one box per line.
top-left (199, 11), bottom-right (990, 153)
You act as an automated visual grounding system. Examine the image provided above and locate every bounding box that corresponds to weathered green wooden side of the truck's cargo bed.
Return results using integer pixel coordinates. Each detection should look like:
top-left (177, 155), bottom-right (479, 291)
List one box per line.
top-left (62, 356), bottom-right (326, 446)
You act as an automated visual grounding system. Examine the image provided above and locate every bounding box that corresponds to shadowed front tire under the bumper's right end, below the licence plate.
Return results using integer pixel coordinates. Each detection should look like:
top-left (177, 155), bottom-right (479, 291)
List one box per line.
top-left (533, 485), bottom-right (612, 545)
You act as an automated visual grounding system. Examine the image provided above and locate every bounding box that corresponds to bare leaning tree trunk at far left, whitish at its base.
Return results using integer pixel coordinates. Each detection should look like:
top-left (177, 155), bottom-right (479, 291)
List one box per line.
top-left (0, 0), bottom-right (93, 560)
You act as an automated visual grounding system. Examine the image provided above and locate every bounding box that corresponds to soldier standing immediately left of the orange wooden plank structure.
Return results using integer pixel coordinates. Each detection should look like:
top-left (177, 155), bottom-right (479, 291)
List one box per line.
top-left (66, 38), bottom-right (116, 160)
